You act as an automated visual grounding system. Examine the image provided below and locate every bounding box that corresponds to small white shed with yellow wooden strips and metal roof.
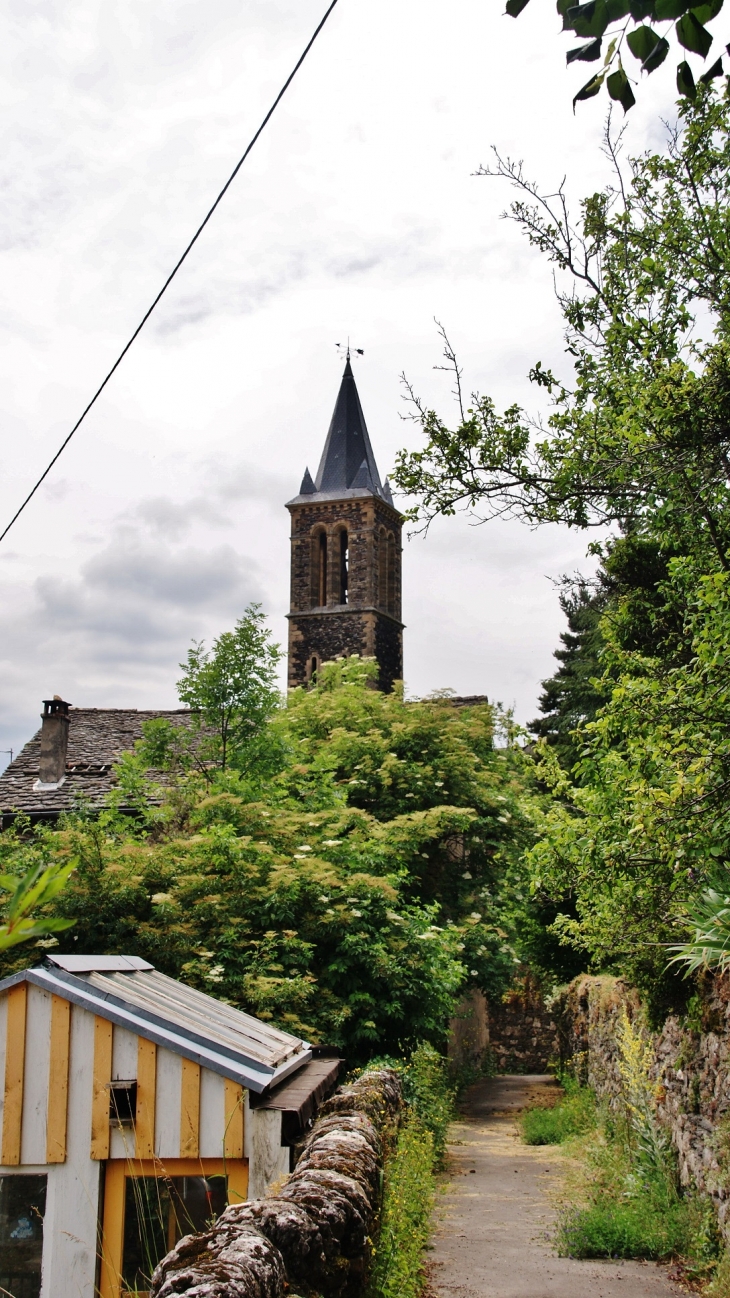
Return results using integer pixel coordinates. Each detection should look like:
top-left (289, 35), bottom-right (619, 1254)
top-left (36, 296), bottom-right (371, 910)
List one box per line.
top-left (0, 955), bottom-right (338, 1298)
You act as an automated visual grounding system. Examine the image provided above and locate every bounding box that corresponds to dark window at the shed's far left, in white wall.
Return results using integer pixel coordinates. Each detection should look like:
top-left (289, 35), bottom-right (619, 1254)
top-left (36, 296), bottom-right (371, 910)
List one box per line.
top-left (0, 1175), bottom-right (45, 1298)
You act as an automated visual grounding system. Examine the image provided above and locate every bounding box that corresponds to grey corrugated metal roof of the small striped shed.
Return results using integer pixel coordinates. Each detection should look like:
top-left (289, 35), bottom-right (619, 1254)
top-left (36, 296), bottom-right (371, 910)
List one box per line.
top-left (0, 966), bottom-right (312, 1094)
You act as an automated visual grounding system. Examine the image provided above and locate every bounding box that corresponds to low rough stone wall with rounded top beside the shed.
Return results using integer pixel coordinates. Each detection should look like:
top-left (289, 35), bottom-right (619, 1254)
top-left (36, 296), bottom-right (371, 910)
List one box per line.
top-left (151, 1068), bottom-right (403, 1298)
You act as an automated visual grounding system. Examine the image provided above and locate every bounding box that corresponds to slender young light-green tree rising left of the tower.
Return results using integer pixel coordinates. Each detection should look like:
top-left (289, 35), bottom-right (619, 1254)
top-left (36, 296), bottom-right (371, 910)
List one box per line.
top-left (175, 604), bottom-right (282, 770)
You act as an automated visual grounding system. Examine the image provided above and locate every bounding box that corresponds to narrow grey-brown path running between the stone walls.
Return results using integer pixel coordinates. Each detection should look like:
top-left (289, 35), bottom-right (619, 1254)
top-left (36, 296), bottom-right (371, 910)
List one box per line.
top-left (429, 1077), bottom-right (683, 1298)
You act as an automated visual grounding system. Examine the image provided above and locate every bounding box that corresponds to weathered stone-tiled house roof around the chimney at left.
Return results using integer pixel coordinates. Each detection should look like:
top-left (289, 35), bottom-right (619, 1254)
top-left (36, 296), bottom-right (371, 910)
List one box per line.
top-left (0, 707), bottom-right (192, 824)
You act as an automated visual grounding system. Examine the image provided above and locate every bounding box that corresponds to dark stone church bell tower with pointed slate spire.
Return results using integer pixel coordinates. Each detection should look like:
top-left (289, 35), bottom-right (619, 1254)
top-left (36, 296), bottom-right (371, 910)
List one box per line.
top-left (287, 354), bottom-right (403, 691)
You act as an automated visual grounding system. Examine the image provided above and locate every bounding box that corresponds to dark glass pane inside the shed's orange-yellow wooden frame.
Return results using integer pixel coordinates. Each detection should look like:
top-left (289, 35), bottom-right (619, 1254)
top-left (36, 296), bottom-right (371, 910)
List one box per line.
top-left (122, 1176), bottom-right (227, 1294)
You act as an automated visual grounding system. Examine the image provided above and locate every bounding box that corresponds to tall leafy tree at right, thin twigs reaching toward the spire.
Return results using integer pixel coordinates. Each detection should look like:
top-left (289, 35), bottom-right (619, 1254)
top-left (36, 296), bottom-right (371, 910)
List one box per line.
top-left (399, 90), bottom-right (730, 1015)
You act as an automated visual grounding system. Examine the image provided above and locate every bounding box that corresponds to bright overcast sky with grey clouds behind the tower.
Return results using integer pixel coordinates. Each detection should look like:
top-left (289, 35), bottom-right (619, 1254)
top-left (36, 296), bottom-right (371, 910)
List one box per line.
top-left (0, 0), bottom-right (673, 762)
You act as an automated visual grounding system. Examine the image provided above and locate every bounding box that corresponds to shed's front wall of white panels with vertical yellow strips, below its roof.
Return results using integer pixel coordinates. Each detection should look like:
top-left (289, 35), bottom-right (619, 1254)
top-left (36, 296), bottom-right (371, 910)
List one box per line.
top-left (0, 983), bottom-right (288, 1298)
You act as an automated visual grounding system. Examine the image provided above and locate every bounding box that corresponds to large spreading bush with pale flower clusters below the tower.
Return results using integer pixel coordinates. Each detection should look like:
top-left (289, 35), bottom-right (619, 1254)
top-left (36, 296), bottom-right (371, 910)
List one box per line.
top-left (4, 658), bottom-right (531, 1062)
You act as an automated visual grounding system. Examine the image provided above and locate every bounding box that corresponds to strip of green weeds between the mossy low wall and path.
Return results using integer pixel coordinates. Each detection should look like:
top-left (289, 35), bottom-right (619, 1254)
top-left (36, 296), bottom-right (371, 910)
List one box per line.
top-left (368, 1114), bottom-right (434, 1298)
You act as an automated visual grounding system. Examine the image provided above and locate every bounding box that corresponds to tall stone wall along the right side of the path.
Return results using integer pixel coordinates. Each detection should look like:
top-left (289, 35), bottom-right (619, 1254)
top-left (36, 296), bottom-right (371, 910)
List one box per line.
top-left (555, 975), bottom-right (730, 1237)
